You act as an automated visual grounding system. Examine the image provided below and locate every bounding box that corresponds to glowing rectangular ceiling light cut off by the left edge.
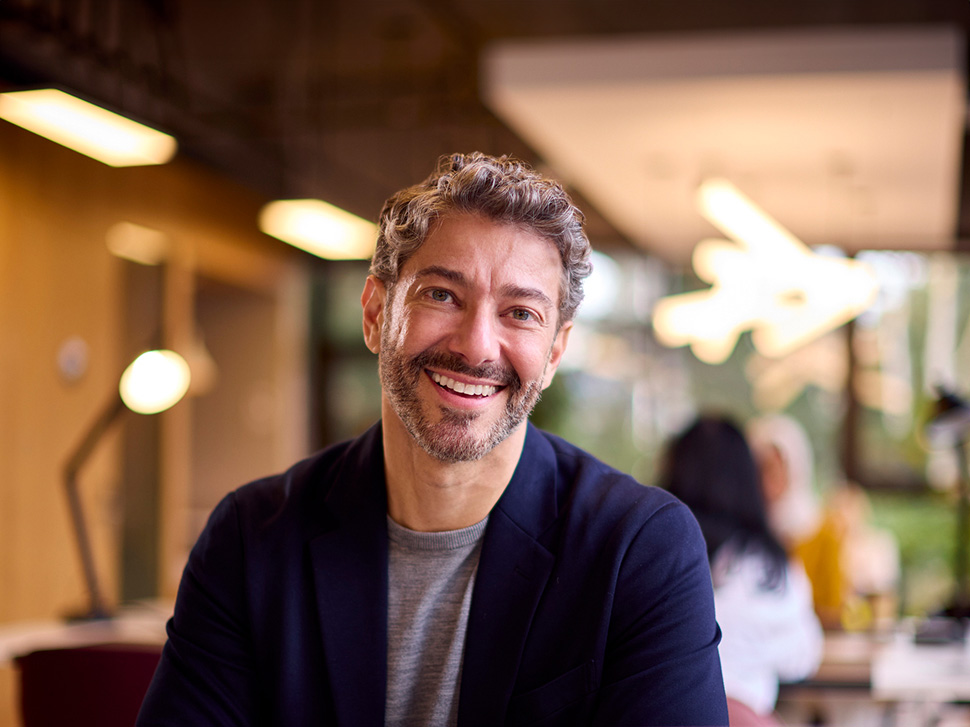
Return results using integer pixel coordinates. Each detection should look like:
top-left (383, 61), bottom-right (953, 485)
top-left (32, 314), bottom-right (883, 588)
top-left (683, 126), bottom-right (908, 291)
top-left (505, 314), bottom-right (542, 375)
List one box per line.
top-left (0, 88), bottom-right (177, 167)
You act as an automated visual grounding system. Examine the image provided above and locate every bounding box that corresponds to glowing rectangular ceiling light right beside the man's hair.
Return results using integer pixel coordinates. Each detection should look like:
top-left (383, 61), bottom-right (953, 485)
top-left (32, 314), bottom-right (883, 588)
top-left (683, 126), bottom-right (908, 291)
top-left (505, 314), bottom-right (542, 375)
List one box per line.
top-left (259, 199), bottom-right (377, 260)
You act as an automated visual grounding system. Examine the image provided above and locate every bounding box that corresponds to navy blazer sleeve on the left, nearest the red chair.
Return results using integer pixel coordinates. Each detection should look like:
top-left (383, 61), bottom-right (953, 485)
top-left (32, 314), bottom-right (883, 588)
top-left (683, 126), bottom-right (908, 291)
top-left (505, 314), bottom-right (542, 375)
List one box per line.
top-left (136, 494), bottom-right (257, 727)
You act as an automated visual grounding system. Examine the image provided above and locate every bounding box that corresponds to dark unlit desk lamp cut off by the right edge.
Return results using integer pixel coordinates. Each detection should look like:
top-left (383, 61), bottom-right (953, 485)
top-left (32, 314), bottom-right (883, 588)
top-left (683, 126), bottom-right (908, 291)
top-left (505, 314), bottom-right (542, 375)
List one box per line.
top-left (925, 387), bottom-right (970, 618)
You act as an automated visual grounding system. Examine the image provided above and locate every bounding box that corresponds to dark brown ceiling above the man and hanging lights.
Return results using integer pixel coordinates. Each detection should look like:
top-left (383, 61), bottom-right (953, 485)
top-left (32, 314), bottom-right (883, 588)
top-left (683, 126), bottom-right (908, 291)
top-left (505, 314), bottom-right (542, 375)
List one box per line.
top-left (0, 0), bottom-right (970, 249)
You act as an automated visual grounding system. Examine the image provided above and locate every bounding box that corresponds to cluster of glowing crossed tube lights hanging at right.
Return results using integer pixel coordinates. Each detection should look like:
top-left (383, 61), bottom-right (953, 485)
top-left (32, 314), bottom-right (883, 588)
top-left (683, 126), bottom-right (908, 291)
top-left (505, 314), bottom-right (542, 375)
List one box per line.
top-left (653, 179), bottom-right (878, 364)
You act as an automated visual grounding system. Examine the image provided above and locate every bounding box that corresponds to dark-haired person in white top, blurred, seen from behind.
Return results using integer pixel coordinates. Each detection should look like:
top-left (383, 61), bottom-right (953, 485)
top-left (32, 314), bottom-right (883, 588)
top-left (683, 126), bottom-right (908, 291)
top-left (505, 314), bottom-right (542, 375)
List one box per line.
top-left (661, 416), bottom-right (823, 727)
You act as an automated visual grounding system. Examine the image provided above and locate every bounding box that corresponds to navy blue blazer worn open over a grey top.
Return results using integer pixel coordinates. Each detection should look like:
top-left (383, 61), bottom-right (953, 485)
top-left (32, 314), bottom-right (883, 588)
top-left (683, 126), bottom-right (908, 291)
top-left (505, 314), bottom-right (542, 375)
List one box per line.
top-left (138, 424), bottom-right (727, 727)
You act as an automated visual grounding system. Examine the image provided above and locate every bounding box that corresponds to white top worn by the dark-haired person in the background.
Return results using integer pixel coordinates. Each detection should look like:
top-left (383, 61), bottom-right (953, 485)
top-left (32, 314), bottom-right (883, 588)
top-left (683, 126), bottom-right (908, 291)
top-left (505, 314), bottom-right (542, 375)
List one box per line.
top-left (711, 543), bottom-right (823, 714)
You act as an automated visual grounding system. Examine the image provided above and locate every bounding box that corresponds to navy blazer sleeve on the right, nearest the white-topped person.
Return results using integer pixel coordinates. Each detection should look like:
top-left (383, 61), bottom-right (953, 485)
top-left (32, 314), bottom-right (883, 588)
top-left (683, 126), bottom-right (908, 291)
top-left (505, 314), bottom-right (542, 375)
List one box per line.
top-left (594, 502), bottom-right (728, 727)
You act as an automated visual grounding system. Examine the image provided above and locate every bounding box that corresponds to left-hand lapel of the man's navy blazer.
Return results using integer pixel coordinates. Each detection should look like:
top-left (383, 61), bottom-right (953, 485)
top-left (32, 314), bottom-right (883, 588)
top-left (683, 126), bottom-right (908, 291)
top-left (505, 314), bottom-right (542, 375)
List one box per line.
top-left (309, 426), bottom-right (387, 727)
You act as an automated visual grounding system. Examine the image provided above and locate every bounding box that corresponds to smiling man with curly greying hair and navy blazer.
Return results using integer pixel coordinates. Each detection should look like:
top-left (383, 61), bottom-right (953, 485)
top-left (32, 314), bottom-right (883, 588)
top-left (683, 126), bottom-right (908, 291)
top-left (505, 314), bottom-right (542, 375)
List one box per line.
top-left (138, 153), bottom-right (727, 727)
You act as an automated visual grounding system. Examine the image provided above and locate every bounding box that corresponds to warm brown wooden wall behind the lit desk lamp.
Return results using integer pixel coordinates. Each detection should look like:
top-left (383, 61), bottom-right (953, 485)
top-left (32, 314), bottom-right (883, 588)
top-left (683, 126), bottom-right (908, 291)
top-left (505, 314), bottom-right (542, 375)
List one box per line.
top-left (0, 122), bottom-right (305, 625)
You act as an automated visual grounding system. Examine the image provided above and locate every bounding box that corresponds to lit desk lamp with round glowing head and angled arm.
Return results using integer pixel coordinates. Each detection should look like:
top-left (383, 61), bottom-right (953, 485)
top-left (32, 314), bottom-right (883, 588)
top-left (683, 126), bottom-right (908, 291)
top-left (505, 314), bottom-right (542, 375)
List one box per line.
top-left (64, 350), bottom-right (190, 619)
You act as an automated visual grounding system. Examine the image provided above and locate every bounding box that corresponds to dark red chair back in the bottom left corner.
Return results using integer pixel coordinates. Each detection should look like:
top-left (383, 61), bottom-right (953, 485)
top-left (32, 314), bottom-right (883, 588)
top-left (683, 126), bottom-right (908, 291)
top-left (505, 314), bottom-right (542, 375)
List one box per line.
top-left (15, 644), bottom-right (162, 727)
